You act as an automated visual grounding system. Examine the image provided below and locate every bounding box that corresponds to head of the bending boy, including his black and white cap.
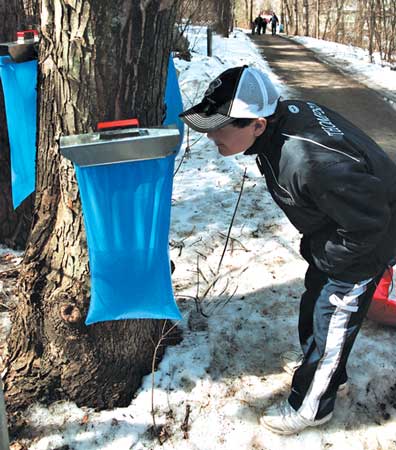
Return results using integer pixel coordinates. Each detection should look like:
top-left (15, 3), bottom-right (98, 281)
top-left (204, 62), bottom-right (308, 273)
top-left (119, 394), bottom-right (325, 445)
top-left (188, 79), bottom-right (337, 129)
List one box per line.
top-left (180, 66), bottom-right (279, 156)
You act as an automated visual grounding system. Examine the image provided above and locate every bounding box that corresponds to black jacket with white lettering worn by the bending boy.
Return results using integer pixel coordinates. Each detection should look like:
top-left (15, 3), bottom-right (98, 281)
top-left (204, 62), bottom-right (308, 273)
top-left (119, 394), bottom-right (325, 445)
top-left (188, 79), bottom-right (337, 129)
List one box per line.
top-left (245, 101), bottom-right (396, 282)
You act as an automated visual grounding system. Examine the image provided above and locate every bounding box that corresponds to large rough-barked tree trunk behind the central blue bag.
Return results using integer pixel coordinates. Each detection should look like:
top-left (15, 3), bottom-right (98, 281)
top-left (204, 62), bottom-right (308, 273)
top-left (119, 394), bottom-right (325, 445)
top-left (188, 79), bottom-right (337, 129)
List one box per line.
top-left (5, 0), bottom-right (180, 411)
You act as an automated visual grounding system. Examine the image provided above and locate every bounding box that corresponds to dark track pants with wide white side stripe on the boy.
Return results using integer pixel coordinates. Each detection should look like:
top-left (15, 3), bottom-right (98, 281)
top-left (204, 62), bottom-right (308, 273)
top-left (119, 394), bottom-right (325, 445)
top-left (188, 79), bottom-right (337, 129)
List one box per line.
top-left (289, 265), bottom-right (382, 420)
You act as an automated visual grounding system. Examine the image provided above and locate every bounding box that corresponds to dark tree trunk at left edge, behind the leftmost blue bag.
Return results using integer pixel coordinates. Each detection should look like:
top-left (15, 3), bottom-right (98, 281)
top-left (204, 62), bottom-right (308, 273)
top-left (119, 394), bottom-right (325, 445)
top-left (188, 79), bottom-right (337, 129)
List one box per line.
top-left (0, 0), bottom-right (33, 249)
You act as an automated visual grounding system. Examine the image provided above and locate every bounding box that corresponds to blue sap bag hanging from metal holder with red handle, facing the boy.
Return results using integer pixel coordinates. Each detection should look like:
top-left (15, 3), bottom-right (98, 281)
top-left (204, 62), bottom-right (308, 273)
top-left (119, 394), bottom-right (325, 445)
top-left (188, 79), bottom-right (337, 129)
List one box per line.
top-left (60, 119), bottom-right (181, 325)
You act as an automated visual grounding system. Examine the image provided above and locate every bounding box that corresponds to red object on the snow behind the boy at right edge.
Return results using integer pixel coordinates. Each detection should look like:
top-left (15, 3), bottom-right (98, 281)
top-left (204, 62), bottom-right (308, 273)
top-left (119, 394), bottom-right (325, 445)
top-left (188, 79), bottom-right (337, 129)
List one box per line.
top-left (367, 267), bottom-right (396, 327)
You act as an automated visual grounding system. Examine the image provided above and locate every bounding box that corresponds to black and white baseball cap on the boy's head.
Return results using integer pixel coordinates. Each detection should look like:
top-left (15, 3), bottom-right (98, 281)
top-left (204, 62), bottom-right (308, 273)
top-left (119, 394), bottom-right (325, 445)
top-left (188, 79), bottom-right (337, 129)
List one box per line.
top-left (180, 66), bottom-right (279, 133)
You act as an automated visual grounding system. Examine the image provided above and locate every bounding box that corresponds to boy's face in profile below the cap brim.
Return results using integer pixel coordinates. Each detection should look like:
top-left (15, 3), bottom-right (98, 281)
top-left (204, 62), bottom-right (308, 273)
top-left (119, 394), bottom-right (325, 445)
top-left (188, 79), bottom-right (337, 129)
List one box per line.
top-left (207, 118), bottom-right (267, 156)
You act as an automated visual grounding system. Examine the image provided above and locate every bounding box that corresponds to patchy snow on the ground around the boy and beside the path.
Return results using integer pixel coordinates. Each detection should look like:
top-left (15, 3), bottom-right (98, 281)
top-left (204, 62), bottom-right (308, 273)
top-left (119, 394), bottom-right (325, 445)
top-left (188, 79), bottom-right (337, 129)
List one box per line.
top-left (3, 28), bottom-right (396, 450)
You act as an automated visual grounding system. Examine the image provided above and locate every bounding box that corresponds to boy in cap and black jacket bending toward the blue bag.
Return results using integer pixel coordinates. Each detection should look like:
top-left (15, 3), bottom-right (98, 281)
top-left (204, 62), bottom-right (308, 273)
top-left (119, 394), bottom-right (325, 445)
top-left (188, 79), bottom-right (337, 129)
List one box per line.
top-left (180, 66), bottom-right (396, 434)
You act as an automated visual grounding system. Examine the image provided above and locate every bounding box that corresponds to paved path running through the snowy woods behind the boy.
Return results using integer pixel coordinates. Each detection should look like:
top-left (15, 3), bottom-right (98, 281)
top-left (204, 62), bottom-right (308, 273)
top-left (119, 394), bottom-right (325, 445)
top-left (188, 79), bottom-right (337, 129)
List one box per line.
top-left (251, 34), bottom-right (396, 161)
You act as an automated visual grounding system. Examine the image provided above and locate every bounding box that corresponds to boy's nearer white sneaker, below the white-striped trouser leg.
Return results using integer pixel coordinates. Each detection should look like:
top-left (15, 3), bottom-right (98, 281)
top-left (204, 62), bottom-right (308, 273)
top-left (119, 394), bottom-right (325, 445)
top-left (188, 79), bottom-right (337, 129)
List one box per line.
top-left (260, 400), bottom-right (333, 435)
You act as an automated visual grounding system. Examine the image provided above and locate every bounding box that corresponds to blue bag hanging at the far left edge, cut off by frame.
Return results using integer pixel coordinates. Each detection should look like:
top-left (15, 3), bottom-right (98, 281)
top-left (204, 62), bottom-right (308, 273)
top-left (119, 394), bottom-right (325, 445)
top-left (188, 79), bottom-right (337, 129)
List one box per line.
top-left (0, 56), bottom-right (37, 209)
